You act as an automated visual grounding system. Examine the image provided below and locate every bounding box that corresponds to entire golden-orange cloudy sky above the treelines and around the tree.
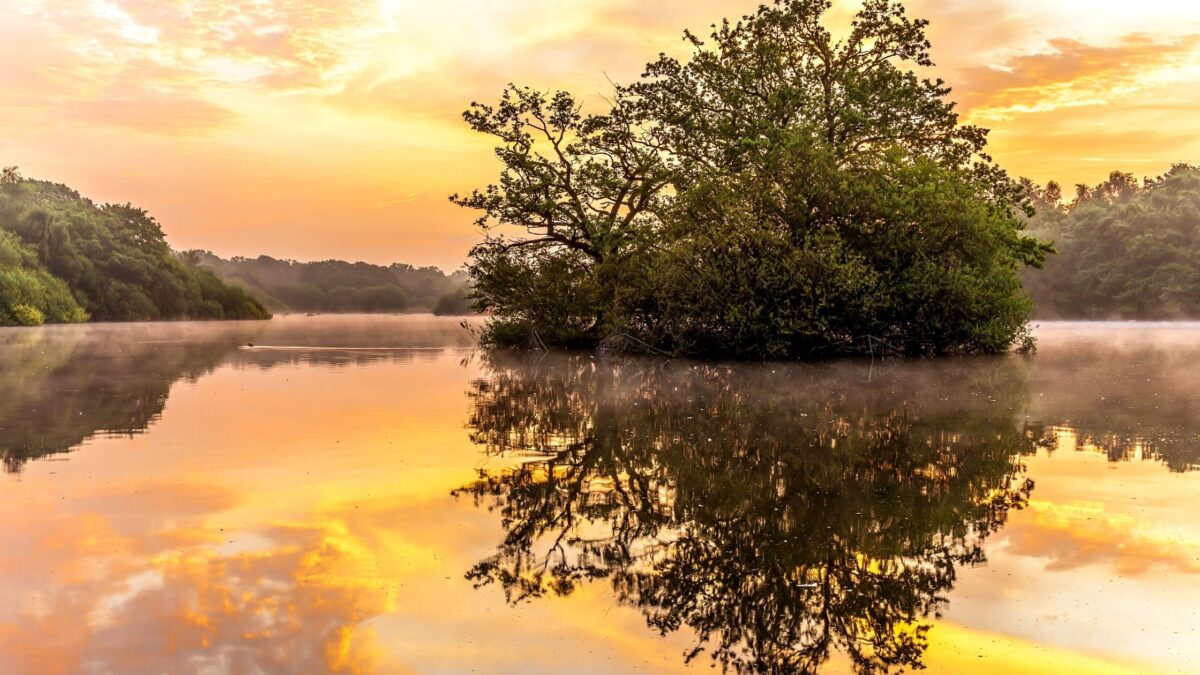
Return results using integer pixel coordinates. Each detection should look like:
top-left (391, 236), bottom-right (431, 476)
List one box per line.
top-left (0, 0), bottom-right (1200, 269)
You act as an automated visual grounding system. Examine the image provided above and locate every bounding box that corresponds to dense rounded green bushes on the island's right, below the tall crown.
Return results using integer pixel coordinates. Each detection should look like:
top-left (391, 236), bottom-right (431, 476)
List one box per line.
top-left (624, 143), bottom-right (1040, 357)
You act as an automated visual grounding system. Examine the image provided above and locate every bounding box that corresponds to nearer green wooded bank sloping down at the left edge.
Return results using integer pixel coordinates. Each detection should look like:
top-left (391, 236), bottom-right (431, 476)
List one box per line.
top-left (0, 167), bottom-right (270, 325)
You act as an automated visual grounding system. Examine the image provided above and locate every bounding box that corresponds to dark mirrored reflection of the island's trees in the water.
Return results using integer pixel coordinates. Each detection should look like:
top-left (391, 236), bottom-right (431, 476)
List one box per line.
top-left (456, 356), bottom-right (1033, 673)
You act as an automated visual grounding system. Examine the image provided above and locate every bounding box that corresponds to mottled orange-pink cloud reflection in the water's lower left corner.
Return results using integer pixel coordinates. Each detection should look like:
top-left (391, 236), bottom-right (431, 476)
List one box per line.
top-left (0, 484), bottom-right (396, 674)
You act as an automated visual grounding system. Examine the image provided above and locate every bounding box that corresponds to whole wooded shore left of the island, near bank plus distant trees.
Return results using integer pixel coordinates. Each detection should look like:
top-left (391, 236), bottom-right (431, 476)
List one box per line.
top-left (0, 167), bottom-right (470, 325)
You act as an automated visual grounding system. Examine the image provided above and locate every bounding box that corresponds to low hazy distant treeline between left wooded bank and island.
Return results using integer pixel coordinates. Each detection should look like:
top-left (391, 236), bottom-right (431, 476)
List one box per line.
top-left (184, 251), bottom-right (470, 315)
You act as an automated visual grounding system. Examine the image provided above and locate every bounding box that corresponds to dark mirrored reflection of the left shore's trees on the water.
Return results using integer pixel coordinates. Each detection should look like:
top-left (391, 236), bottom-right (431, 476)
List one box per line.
top-left (0, 315), bottom-right (469, 473)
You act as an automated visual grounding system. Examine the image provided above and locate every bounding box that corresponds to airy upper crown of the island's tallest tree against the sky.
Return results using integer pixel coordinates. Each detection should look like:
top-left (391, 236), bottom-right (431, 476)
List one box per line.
top-left (624, 0), bottom-right (986, 178)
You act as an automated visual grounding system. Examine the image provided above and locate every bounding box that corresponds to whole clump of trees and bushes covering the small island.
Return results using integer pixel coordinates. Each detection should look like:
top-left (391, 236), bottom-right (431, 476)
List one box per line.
top-left (451, 0), bottom-right (1049, 358)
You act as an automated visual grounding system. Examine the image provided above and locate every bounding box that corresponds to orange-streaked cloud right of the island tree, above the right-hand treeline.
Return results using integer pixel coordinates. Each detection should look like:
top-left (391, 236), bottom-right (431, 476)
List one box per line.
top-left (940, 32), bottom-right (1200, 184)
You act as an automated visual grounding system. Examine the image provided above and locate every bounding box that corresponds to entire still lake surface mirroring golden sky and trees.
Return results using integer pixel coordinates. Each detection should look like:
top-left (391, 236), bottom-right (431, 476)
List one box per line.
top-left (0, 316), bottom-right (1200, 674)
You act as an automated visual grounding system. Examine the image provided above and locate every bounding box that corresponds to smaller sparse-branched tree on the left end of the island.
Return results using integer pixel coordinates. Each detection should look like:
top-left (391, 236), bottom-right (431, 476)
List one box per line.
top-left (451, 86), bottom-right (671, 344)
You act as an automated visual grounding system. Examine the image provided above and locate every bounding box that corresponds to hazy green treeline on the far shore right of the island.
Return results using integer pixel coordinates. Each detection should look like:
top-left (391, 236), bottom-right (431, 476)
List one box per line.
top-left (1022, 165), bottom-right (1200, 319)
